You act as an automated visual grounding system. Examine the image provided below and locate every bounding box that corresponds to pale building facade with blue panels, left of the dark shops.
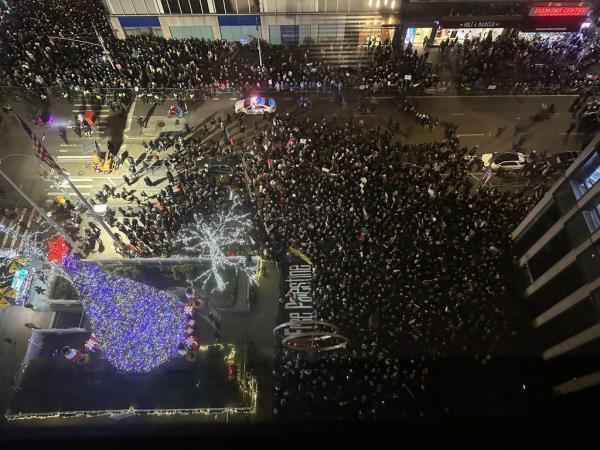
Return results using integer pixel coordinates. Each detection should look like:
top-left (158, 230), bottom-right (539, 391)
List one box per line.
top-left (103, 0), bottom-right (400, 44)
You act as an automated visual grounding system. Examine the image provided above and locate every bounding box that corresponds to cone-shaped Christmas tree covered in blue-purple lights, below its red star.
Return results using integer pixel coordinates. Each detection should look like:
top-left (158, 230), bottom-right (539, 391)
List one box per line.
top-left (63, 255), bottom-right (186, 373)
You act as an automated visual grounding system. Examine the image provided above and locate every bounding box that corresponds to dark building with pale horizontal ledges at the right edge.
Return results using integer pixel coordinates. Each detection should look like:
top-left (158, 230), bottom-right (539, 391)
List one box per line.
top-left (512, 135), bottom-right (600, 401)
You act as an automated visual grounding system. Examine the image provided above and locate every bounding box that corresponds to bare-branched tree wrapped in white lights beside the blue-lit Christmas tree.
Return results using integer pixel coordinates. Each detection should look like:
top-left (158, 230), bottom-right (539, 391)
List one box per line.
top-left (174, 207), bottom-right (258, 291)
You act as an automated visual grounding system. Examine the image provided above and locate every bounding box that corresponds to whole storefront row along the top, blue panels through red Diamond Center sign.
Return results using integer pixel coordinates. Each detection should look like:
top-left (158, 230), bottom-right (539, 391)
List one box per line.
top-left (103, 0), bottom-right (590, 47)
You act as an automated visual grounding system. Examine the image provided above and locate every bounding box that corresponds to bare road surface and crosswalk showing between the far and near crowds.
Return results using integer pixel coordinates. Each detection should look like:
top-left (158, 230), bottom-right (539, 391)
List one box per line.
top-left (0, 93), bottom-right (584, 211)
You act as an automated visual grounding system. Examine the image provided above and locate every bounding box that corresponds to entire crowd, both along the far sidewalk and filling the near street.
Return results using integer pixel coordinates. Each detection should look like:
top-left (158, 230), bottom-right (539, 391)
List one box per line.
top-left (0, 0), bottom-right (600, 419)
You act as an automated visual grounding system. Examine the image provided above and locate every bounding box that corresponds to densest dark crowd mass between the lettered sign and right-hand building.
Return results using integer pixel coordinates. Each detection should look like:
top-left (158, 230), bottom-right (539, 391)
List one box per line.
top-left (237, 110), bottom-right (537, 418)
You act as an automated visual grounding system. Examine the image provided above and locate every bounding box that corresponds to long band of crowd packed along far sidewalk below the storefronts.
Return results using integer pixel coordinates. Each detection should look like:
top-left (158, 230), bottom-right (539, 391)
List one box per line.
top-left (0, 0), bottom-right (600, 98)
